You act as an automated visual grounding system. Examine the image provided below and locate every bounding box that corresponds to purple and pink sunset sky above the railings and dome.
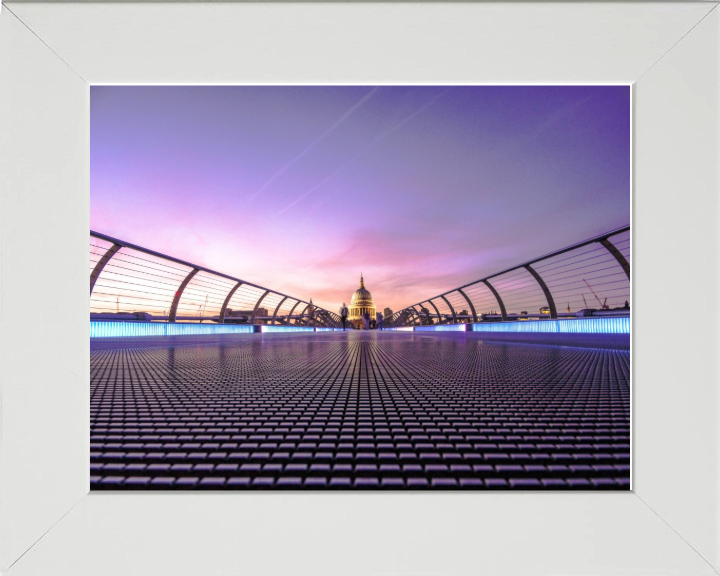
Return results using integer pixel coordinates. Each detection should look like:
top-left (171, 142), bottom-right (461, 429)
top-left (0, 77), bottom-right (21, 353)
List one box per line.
top-left (90, 86), bottom-right (630, 310)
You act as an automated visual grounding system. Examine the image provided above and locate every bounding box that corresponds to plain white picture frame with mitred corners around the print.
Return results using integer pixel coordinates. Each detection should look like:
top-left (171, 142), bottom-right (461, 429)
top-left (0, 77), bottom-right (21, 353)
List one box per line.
top-left (0, 2), bottom-right (720, 576)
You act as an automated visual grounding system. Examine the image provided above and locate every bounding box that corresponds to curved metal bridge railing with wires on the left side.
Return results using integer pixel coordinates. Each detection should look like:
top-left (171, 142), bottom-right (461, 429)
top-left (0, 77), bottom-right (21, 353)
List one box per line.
top-left (90, 231), bottom-right (341, 327)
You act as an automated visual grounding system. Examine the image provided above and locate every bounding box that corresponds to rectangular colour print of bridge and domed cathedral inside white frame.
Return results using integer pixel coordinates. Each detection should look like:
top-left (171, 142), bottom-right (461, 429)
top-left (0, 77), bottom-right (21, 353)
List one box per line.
top-left (89, 85), bottom-right (631, 491)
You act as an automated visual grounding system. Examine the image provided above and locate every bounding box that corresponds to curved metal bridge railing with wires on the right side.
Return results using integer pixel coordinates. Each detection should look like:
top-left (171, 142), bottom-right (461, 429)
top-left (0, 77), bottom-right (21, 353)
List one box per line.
top-left (388, 226), bottom-right (630, 327)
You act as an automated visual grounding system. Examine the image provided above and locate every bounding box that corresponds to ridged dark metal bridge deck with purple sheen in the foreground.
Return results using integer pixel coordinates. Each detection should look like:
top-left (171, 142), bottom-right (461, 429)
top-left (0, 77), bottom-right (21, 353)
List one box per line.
top-left (90, 331), bottom-right (630, 490)
